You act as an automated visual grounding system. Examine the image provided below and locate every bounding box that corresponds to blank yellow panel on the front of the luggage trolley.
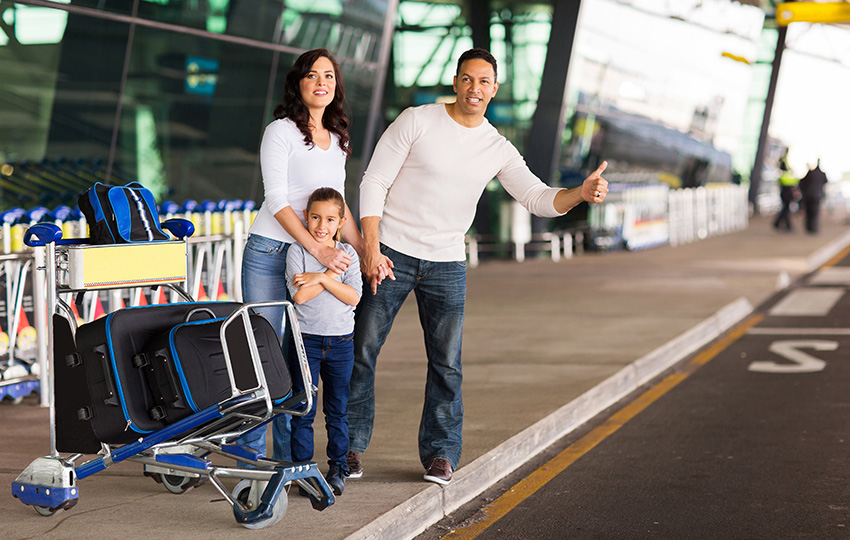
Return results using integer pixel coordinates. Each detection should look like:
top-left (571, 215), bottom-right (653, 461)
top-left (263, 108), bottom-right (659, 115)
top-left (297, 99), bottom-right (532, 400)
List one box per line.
top-left (68, 242), bottom-right (186, 289)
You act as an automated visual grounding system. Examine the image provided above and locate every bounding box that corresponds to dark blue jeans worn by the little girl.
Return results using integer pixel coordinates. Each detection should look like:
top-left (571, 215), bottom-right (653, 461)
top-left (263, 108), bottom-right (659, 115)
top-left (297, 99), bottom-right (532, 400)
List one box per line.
top-left (290, 334), bottom-right (354, 470)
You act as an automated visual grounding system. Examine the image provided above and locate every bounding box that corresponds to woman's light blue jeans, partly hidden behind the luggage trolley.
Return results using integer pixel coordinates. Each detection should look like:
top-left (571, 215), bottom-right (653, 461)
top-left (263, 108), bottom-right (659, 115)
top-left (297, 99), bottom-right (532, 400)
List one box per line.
top-left (236, 234), bottom-right (292, 461)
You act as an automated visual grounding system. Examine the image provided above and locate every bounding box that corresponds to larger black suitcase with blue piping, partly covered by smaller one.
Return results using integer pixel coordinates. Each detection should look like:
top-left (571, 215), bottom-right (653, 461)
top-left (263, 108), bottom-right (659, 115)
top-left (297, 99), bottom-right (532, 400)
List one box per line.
top-left (71, 302), bottom-right (241, 444)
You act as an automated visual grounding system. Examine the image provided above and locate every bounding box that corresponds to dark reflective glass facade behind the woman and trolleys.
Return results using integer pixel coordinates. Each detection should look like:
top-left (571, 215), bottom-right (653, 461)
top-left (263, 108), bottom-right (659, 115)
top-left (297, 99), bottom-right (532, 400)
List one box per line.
top-left (0, 0), bottom-right (389, 210)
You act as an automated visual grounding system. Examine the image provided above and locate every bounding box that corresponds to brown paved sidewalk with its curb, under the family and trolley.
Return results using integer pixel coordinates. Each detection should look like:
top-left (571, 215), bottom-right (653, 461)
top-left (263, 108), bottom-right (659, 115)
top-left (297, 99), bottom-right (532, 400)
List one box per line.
top-left (0, 216), bottom-right (850, 540)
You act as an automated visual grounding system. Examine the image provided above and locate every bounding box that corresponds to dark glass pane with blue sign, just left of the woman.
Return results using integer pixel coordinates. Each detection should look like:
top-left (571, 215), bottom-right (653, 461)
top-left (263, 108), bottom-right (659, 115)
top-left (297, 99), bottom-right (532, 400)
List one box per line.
top-left (116, 26), bottom-right (274, 200)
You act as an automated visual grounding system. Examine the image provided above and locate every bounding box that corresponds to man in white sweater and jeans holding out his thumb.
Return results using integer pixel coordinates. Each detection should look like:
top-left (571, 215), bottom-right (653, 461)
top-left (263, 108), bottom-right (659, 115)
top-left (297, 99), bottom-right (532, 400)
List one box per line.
top-left (348, 49), bottom-right (608, 485)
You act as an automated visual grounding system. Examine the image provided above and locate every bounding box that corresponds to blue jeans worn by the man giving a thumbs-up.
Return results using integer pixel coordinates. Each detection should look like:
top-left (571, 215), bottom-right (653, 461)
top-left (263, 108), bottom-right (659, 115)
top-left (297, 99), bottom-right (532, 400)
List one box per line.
top-left (348, 245), bottom-right (466, 468)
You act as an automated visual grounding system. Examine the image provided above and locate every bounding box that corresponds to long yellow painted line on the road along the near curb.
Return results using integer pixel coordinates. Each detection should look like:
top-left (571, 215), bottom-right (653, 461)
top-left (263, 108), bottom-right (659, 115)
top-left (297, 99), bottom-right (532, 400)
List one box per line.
top-left (442, 315), bottom-right (764, 540)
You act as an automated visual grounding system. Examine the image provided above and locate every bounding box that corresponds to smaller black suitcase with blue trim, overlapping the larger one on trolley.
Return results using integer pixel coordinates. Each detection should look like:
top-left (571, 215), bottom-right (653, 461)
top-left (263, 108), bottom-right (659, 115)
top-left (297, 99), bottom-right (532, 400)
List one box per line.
top-left (133, 307), bottom-right (292, 424)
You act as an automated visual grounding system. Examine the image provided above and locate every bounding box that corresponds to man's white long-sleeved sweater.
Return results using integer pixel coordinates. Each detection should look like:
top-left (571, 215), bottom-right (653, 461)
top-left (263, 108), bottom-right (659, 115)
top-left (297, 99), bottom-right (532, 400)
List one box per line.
top-left (360, 104), bottom-right (560, 261)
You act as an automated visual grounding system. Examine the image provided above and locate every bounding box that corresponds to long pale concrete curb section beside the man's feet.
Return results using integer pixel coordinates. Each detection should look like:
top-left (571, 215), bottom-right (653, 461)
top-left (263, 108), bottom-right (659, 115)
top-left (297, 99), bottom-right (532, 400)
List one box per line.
top-left (346, 298), bottom-right (753, 540)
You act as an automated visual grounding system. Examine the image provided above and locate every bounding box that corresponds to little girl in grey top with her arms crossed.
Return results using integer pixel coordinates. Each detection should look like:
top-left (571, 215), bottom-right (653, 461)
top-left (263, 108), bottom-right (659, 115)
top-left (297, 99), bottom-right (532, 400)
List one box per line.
top-left (286, 187), bottom-right (363, 495)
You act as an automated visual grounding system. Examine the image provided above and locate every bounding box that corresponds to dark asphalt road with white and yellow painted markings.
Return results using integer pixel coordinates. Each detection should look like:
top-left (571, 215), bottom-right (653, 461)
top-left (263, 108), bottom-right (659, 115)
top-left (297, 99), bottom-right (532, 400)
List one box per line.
top-left (420, 251), bottom-right (850, 540)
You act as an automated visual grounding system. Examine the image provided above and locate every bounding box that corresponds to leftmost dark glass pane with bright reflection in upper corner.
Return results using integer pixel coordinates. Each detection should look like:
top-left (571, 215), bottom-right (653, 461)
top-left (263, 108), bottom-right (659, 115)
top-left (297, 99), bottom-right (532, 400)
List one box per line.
top-left (0, 4), bottom-right (129, 209)
